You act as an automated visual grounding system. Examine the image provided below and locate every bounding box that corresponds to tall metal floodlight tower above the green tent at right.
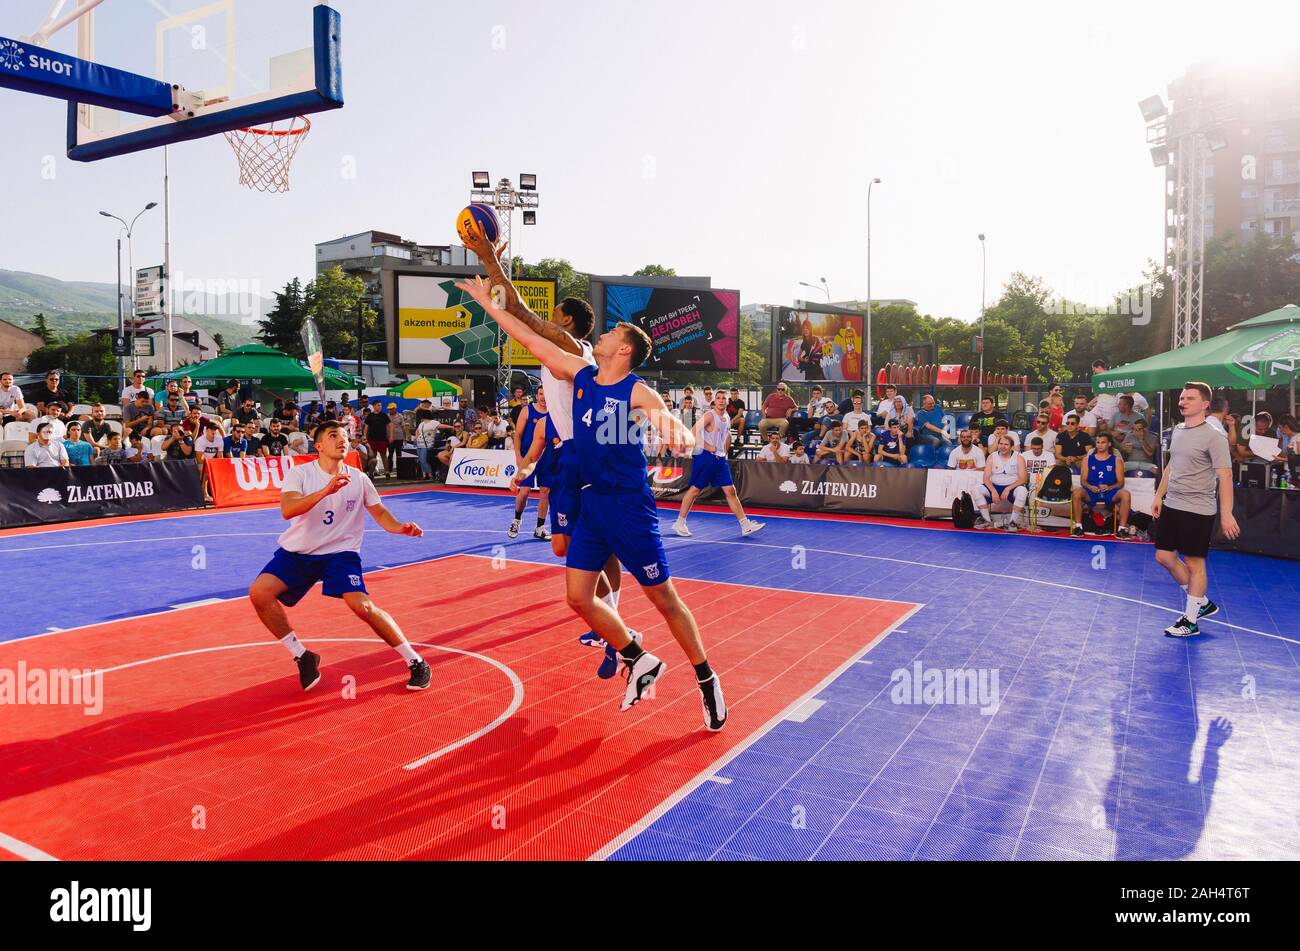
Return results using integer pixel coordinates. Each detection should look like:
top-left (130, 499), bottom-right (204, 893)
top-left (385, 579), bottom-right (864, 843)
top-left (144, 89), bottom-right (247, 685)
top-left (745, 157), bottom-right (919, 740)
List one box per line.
top-left (1138, 78), bottom-right (1231, 349)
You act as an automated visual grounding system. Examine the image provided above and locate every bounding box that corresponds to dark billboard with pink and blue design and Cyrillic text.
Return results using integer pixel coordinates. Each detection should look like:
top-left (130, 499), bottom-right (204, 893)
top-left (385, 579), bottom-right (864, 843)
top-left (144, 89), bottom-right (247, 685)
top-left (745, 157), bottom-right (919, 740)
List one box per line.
top-left (605, 285), bottom-right (740, 370)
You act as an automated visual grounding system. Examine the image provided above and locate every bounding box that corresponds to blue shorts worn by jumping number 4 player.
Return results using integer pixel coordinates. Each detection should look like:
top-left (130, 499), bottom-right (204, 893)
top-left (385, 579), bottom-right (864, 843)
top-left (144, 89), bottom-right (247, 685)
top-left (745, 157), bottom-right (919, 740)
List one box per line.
top-left (569, 486), bottom-right (668, 587)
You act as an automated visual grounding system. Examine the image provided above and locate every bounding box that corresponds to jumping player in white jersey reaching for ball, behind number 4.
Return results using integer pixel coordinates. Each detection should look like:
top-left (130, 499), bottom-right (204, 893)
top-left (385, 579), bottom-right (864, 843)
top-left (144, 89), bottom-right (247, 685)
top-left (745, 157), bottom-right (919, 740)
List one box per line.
top-left (462, 229), bottom-right (641, 679)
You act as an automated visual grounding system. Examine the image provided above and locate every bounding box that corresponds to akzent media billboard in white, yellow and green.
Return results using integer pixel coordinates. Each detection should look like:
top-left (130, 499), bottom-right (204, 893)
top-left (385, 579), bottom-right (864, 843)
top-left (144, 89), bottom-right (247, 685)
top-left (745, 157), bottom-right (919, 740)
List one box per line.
top-left (389, 270), bottom-right (555, 369)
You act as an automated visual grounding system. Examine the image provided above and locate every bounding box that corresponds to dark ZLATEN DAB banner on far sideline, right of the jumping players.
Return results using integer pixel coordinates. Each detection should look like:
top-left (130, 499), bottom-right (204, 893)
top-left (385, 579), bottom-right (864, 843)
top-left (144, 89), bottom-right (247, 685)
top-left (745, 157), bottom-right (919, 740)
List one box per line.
top-left (740, 461), bottom-right (928, 518)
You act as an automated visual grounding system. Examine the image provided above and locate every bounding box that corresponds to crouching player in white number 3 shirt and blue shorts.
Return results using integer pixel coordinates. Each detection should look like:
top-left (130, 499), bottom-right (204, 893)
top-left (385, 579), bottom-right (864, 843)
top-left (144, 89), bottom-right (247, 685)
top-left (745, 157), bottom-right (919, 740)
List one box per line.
top-left (248, 420), bottom-right (429, 690)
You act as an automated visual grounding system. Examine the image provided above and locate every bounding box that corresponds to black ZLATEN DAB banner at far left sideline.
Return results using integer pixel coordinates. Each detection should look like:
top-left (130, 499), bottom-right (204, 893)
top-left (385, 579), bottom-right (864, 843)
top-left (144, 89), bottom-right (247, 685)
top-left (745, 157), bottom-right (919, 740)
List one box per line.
top-left (0, 460), bottom-right (203, 527)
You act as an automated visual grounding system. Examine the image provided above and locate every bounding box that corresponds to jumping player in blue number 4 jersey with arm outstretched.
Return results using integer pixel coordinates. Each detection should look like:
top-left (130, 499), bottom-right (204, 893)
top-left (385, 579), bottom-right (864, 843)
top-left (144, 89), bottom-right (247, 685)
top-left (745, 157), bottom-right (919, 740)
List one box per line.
top-left (456, 271), bottom-right (727, 730)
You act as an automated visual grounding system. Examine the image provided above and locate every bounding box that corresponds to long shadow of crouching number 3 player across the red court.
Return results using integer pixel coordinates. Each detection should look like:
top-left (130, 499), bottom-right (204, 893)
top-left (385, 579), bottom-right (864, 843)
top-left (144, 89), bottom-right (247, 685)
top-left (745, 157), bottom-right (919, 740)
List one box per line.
top-left (0, 646), bottom-right (436, 802)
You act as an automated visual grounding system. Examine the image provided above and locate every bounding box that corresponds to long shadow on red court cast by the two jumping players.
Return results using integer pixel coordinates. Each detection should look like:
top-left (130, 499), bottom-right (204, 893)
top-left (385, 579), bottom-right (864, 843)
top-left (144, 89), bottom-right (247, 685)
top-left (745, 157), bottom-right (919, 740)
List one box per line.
top-left (221, 717), bottom-right (709, 861)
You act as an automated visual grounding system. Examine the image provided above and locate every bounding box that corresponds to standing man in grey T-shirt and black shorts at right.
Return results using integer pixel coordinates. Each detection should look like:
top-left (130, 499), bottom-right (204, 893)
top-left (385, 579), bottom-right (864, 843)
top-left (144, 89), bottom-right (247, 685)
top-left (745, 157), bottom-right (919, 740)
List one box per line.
top-left (1151, 383), bottom-right (1242, 638)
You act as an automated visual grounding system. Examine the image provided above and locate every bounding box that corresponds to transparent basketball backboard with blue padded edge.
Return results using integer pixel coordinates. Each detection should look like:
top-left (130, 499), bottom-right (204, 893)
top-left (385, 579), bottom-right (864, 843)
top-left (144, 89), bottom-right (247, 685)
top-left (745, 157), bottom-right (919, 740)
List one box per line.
top-left (68, 0), bottom-right (343, 161)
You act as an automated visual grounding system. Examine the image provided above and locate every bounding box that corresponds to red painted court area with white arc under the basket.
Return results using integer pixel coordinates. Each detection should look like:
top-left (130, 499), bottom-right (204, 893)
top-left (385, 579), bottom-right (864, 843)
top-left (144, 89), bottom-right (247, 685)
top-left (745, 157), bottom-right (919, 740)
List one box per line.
top-left (0, 555), bottom-right (914, 859)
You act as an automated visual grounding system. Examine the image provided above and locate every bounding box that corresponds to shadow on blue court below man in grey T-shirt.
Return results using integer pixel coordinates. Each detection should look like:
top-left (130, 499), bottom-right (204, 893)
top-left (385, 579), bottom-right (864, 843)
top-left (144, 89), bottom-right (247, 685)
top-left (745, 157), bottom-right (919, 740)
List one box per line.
top-left (1104, 643), bottom-right (1232, 861)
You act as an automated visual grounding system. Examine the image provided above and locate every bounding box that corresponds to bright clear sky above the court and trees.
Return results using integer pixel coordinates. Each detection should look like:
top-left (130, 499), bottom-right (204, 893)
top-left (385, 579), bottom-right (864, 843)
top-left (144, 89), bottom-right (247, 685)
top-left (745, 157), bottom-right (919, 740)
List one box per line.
top-left (0, 0), bottom-right (1300, 320)
